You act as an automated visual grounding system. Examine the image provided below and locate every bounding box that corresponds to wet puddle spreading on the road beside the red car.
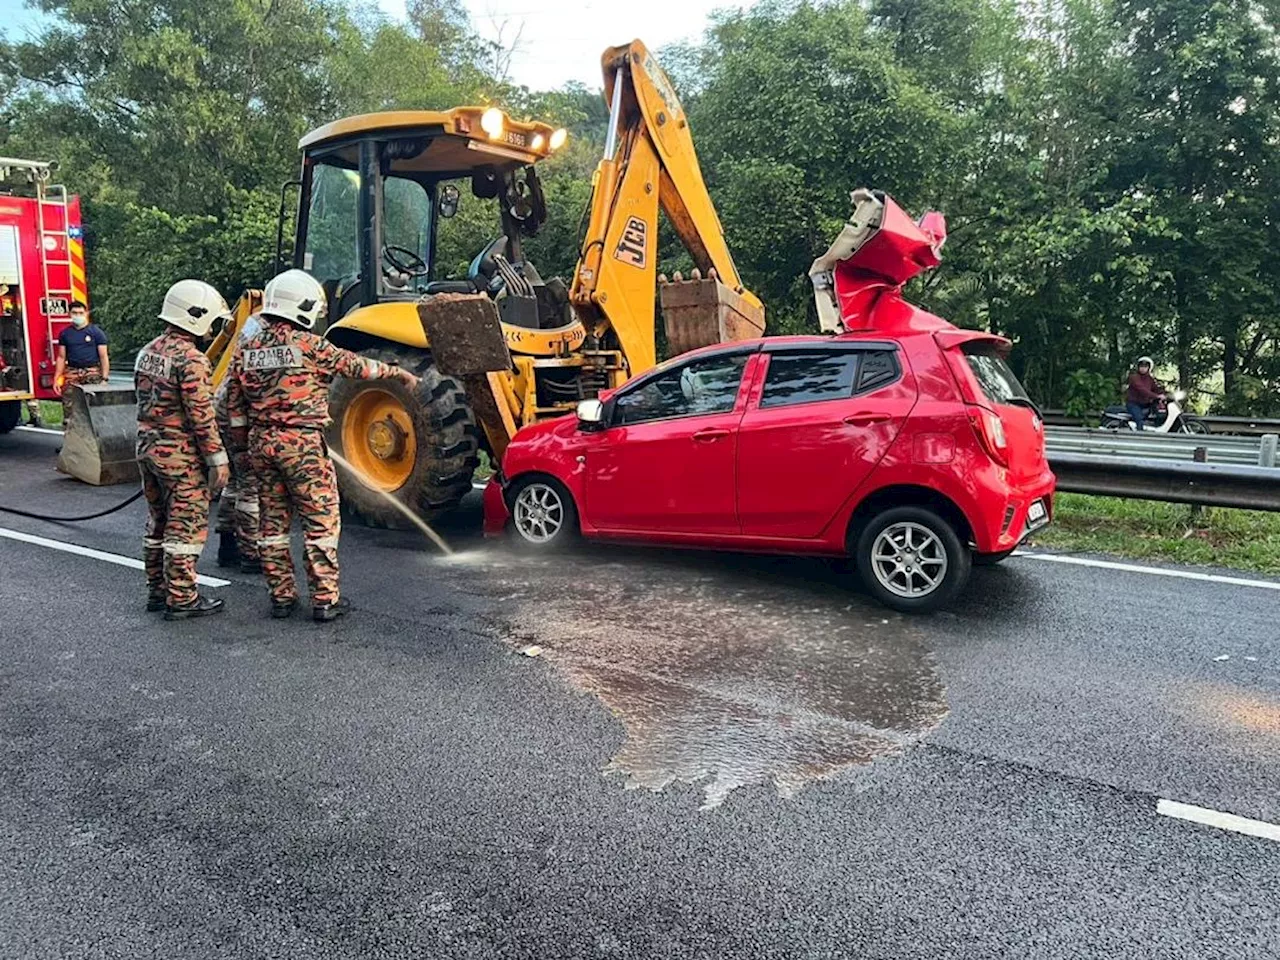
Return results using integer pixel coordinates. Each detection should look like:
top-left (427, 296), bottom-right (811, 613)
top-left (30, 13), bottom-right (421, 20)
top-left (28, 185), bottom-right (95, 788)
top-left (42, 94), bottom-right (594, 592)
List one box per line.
top-left (433, 548), bottom-right (946, 808)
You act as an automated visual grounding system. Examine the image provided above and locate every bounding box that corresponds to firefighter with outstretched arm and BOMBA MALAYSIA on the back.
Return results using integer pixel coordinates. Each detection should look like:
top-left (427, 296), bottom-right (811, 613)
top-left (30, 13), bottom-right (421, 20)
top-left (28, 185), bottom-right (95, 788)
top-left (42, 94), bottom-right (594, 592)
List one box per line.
top-left (228, 270), bottom-right (417, 622)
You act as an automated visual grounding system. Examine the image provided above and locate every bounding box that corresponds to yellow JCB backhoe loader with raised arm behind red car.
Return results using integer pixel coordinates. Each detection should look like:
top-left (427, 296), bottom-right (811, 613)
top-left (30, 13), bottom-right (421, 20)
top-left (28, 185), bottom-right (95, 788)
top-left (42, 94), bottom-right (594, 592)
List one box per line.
top-left (211, 41), bottom-right (764, 526)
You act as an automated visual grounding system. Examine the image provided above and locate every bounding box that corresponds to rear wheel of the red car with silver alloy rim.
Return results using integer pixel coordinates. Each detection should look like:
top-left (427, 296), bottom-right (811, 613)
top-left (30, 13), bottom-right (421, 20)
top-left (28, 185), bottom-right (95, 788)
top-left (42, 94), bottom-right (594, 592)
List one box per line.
top-left (854, 507), bottom-right (972, 613)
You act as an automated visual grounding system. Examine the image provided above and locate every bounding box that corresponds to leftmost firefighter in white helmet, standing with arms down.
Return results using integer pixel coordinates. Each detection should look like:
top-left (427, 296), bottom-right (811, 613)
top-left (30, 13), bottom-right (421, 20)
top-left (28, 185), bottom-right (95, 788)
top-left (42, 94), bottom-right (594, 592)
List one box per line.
top-left (133, 280), bottom-right (230, 620)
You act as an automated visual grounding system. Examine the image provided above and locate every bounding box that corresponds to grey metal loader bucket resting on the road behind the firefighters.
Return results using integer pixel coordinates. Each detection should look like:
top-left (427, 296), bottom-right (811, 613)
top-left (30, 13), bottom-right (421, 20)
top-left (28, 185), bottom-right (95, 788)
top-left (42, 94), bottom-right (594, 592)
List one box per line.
top-left (58, 383), bottom-right (138, 486)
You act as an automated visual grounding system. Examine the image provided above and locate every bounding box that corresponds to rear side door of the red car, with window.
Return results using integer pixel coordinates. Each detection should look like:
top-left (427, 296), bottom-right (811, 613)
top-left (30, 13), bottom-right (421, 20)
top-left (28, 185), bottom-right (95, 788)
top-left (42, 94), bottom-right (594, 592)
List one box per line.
top-left (737, 340), bottom-right (916, 539)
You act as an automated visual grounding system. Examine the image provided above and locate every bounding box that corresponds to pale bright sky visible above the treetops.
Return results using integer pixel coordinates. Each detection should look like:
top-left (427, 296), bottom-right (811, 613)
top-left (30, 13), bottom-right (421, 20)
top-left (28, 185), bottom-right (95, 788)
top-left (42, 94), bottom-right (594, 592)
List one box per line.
top-left (0, 0), bottom-right (742, 90)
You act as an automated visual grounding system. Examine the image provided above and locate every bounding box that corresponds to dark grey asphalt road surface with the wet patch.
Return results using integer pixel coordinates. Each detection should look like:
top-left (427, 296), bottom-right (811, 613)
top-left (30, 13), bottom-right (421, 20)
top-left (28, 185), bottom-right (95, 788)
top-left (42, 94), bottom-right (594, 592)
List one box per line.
top-left (0, 433), bottom-right (1280, 960)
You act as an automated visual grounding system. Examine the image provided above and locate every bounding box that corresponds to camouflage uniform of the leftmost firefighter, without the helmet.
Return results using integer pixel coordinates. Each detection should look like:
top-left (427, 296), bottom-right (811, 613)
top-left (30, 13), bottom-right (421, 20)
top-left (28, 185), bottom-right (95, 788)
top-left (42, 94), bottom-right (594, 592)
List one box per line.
top-left (133, 329), bottom-right (227, 607)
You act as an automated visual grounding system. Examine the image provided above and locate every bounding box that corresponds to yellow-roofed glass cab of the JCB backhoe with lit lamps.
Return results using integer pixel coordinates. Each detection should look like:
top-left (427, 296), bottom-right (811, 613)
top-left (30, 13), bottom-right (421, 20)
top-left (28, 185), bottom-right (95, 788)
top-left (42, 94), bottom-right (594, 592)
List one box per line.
top-left (293, 106), bottom-right (567, 335)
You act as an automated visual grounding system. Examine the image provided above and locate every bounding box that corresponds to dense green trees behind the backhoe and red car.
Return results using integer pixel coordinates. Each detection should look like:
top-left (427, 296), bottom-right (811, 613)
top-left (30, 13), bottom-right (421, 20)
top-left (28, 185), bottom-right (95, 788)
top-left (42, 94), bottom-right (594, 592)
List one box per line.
top-left (0, 0), bottom-right (1280, 413)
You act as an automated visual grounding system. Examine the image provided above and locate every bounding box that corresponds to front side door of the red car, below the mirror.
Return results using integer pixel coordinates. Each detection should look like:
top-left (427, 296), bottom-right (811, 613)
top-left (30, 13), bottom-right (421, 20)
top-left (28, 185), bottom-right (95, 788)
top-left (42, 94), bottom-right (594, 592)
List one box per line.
top-left (585, 347), bottom-right (758, 535)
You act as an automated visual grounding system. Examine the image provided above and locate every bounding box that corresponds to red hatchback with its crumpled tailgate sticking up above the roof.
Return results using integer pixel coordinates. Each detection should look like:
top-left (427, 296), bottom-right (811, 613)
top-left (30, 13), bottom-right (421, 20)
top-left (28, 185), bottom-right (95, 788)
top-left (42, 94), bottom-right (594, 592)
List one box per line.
top-left (485, 191), bottom-right (1055, 612)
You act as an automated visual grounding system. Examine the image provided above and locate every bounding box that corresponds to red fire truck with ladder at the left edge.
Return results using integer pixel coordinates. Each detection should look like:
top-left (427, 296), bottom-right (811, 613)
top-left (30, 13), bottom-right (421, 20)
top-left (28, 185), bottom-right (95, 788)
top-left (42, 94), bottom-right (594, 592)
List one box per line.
top-left (0, 157), bottom-right (88, 434)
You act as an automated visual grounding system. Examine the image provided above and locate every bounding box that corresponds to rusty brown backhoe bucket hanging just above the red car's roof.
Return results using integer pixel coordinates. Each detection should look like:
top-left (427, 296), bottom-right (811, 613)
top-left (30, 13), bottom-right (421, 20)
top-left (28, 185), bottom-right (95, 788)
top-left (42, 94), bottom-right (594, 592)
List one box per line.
top-left (658, 270), bottom-right (764, 357)
